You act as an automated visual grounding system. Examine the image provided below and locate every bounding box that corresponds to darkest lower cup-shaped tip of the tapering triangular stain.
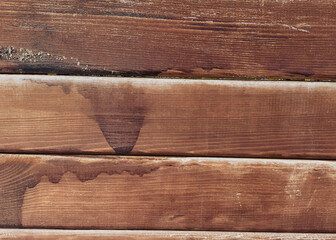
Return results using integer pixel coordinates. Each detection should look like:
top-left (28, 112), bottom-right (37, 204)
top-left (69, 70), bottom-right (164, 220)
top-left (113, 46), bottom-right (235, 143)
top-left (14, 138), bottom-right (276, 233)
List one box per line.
top-left (96, 114), bottom-right (144, 154)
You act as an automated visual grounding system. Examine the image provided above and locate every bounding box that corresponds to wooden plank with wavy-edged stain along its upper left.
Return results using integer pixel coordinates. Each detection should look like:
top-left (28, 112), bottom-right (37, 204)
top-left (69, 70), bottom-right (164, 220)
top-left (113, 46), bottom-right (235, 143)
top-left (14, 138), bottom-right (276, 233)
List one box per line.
top-left (0, 155), bottom-right (336, 233)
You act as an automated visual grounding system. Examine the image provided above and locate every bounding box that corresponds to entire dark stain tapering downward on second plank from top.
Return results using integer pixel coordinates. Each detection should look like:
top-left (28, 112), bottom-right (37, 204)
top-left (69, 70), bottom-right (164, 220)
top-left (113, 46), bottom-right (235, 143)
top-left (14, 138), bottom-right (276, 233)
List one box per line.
top-left (29, 80), bottom-right (146, 154)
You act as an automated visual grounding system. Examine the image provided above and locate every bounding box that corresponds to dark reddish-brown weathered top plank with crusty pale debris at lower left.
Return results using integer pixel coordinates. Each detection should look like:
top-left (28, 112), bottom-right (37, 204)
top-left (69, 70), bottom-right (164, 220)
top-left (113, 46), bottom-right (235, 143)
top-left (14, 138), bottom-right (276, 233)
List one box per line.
top-left (0, 0), bottom-right (336, 79)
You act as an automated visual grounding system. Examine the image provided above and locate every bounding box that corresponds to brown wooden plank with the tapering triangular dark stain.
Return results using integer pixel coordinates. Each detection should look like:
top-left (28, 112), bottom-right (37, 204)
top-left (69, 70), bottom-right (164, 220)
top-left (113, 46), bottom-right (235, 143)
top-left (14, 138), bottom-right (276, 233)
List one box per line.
top-left (0, 75), bottom-right (336, 159)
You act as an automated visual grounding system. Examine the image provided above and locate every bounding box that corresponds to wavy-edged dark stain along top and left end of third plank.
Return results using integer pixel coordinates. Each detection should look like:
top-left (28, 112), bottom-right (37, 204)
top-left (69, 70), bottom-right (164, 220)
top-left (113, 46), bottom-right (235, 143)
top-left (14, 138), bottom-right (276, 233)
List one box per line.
top-left (0, 156), bottom-right (174, 227)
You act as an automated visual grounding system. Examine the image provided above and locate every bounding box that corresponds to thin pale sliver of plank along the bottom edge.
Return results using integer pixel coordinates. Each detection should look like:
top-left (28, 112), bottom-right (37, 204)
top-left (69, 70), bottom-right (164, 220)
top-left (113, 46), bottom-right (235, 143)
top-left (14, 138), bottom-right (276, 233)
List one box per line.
top-left (0, 229), bottom-right (336, 240)
